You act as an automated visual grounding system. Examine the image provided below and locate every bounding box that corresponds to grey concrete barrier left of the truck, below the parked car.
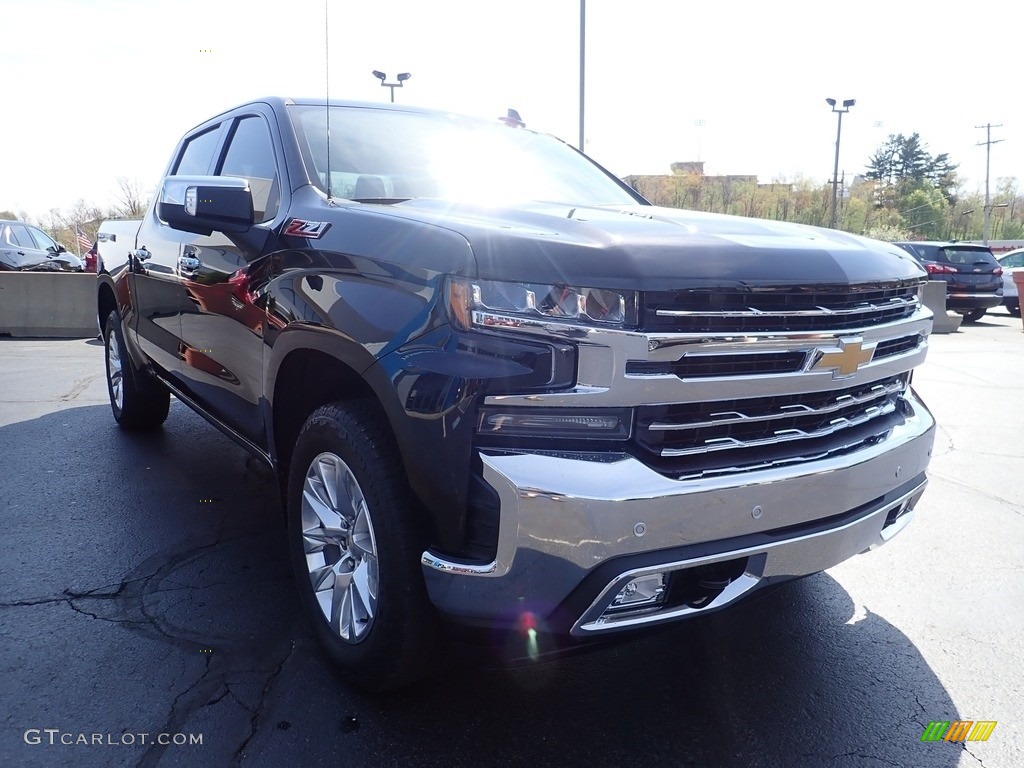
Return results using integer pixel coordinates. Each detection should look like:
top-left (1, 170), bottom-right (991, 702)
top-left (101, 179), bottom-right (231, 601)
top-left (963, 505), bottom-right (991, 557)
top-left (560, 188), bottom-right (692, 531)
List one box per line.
top-left (0, 271), bottom-right (97, 338)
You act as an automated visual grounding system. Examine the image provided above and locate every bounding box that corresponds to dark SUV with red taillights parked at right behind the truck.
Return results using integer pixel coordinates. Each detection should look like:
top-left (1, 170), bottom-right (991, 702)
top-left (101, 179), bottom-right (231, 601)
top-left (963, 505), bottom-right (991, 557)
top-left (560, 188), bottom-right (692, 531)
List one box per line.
top-left (893, 242), bottom-right (1002, 323)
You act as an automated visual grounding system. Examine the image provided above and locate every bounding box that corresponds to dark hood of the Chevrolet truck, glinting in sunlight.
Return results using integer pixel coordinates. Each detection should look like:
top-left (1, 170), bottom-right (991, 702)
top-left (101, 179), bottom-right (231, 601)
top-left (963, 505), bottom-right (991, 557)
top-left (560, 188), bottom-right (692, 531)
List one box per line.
top-left (387, 200), bottom-right (925, 290)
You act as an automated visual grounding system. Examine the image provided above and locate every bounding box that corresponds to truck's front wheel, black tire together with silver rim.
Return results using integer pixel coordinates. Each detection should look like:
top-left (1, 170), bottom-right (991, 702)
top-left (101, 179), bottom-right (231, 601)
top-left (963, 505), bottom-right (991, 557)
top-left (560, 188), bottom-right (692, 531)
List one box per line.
top-left (288, 400), bottom-right (439, 691)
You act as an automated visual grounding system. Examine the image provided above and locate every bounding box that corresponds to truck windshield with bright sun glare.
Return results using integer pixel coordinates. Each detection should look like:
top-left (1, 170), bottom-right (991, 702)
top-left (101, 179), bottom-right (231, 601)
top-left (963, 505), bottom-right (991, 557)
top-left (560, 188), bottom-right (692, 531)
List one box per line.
top-left (289, 105), bottom-right (637, 206)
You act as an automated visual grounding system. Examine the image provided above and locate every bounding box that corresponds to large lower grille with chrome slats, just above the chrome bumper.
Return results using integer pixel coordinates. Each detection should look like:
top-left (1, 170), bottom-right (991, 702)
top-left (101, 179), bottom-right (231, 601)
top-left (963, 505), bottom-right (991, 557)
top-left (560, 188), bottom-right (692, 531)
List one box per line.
top-left (634, 374), bottom-right (907, 475)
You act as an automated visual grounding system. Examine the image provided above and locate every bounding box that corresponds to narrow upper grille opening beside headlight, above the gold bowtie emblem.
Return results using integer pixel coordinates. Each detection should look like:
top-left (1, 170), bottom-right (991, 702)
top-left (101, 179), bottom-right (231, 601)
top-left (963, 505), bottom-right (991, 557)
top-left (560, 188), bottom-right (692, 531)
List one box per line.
top-left (643, 281), bottom-right (921, 334)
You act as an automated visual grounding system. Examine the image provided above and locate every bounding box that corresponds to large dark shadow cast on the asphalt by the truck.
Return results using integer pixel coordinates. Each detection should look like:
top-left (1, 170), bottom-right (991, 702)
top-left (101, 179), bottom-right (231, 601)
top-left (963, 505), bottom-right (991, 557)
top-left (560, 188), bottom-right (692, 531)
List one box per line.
top-left (0, 403), bottom-right (963, 768)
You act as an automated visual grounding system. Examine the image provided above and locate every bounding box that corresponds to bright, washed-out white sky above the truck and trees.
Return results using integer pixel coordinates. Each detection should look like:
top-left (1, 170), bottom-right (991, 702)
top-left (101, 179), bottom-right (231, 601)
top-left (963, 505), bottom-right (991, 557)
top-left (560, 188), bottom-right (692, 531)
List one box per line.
top-left (0, 0), bottom-right (1024, 216)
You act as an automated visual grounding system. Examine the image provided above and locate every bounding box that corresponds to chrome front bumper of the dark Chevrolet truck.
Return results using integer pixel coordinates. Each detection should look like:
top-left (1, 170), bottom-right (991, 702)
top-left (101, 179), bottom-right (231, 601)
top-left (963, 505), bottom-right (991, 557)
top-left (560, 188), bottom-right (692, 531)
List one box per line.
top-left (422, 391), bottom-right (935, 635)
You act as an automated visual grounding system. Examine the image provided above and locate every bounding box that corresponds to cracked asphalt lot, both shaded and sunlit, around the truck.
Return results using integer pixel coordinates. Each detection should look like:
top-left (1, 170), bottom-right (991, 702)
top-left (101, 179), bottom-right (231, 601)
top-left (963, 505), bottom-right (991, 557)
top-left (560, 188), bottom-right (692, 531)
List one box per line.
top-left (0, 311), bottom-right (1024, 768)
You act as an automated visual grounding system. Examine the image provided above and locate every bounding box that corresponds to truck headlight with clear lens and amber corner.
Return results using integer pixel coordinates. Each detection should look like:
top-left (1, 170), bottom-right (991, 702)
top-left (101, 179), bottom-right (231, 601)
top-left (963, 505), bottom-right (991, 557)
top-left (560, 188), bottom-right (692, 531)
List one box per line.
top-left (447, 278), bottom-right (637, 330)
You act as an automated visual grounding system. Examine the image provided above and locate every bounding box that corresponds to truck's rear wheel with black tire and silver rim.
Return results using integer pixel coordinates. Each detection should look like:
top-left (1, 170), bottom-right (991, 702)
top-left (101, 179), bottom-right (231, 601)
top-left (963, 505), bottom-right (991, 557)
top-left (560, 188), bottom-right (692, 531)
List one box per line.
top-left (103, 311), bottom-right (171, 430)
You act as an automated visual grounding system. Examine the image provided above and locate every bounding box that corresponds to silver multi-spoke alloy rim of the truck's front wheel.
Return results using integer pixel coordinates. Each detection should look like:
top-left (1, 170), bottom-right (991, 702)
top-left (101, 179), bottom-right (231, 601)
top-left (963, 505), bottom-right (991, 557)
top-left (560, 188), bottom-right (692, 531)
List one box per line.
top-left (301, 453), bottom-right (380, 644)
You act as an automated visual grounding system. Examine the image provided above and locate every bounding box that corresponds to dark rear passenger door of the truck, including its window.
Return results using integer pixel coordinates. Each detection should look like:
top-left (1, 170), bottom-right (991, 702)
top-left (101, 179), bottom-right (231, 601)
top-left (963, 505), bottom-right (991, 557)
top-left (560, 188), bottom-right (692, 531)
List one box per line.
top-left (131, 123), bottom-right (224, 385)
